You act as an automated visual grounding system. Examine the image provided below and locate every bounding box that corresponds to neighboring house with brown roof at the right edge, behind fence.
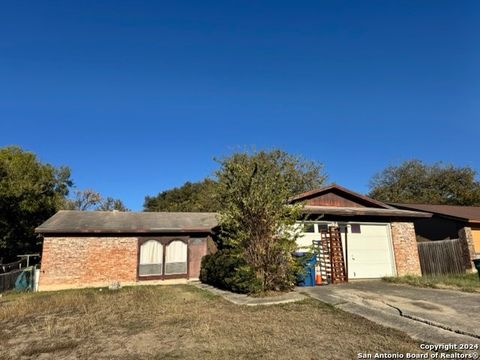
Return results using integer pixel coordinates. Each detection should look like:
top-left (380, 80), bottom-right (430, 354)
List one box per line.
top-left (390, 203), bottom-right (480, 269)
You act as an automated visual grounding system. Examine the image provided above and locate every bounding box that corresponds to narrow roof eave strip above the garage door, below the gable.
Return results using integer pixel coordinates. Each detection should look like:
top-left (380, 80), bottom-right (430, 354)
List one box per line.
top-left (302, 205), bottom-right (432, 218)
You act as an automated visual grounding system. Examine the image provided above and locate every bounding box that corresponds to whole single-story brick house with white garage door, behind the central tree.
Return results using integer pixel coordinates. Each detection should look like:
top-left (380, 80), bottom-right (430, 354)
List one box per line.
top-left (36, 185), bottom-right (431, 290)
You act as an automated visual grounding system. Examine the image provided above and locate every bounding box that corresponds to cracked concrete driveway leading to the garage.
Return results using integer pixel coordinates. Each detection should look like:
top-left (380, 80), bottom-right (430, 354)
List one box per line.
top-left (297, 280), bottom-right (480, 344)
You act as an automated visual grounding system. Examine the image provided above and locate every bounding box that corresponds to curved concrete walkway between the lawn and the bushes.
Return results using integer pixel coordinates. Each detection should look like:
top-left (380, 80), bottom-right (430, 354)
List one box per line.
top-left (191, 282), bottom-right (307, 306)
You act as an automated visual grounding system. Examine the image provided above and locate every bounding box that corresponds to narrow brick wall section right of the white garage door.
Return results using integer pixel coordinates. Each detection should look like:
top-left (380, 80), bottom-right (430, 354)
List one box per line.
top-left (391, 222), bottom-right (422, 276)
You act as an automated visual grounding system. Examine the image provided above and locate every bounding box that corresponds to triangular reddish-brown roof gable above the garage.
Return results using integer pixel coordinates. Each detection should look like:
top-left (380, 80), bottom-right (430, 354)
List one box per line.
top-left (289, 184), bottom-right (393, 209)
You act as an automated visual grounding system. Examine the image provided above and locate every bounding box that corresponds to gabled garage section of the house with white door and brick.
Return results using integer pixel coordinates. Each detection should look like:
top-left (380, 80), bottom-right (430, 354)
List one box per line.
top-left (290, 184), bottom-right (431, 279)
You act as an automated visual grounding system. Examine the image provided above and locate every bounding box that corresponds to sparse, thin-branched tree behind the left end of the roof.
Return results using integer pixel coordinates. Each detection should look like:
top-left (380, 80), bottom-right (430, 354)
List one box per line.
top-left (63, 189), bottom-right (130, 211)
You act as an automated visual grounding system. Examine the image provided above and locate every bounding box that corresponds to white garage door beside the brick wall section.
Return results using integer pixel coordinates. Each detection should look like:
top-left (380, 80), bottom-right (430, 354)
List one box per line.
top-left (341, 223), bottom-right (395, 279)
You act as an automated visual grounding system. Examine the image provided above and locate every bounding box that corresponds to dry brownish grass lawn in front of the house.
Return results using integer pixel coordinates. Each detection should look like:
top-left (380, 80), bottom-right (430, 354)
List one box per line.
top-left (0, 285), bottom-right (419, 359)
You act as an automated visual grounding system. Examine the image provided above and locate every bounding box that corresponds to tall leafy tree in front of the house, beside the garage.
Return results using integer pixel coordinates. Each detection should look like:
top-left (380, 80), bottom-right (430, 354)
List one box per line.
top-left (217, 150), bottom-right (325, 291)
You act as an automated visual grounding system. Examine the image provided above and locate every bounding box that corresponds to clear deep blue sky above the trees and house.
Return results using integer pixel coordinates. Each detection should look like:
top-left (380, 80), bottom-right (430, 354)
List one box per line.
top-left (0, 0), bottom-right (480, 210)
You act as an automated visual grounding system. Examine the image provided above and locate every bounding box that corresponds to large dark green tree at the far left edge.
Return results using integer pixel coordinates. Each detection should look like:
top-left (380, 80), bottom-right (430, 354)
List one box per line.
top-left (0, 146), bottom-right (72, 260)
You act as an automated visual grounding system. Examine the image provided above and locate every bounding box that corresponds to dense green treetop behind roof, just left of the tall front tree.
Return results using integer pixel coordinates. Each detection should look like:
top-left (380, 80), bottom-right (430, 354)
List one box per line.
top-left (143, 178), bottom-right (220, 212)
